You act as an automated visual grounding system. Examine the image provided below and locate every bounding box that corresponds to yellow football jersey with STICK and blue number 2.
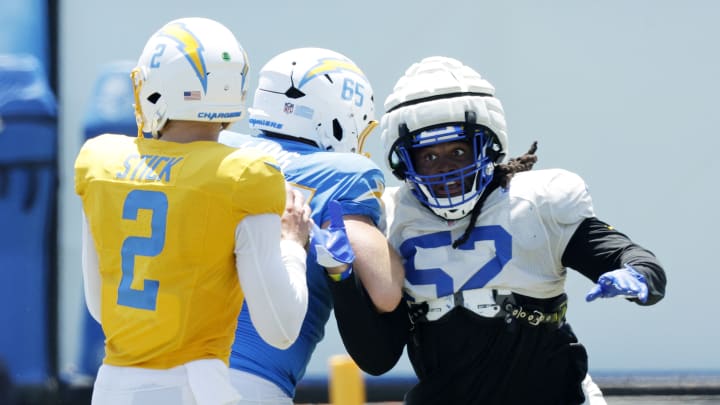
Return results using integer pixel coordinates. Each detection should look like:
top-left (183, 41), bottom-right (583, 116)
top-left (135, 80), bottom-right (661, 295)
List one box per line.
top-left (75, 135), bottom-right (285, 369)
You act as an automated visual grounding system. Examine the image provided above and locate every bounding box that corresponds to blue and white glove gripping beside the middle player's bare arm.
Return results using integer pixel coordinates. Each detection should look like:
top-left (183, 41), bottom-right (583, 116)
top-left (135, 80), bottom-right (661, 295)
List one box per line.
top-left (310, 200), bottom-right (355, 268)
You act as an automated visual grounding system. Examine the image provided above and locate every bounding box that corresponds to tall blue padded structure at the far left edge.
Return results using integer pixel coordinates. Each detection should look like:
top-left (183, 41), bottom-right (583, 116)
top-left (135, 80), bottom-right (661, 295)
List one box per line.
top-left (0, 54), bottom-right (58, 385)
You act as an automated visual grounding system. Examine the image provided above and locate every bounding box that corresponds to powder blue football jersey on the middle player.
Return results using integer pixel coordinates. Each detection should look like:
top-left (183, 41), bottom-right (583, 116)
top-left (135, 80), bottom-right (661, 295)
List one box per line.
top-left (220, 131), bottom-right (385, 398)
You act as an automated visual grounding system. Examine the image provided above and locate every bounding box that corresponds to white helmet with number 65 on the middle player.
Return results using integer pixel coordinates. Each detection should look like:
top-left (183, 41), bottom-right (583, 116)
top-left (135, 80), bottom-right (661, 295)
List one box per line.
top-left (248, 48), bottom-right (377, 152)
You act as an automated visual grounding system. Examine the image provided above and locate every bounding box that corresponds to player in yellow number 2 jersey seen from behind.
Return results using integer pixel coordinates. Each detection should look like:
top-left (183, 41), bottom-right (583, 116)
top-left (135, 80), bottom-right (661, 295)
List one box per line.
top-left (75, 18), bottom-right (311, 405)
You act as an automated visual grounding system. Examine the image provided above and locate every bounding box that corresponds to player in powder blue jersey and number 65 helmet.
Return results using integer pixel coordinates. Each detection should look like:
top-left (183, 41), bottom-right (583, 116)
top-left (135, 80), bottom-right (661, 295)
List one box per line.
top-left (220, 48), bottom-right (403, 404)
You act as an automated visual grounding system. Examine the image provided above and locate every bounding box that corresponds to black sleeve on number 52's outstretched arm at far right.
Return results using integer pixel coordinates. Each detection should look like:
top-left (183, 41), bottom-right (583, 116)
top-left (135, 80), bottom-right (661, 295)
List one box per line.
top-left (562, 218), bottom-right (667, 305)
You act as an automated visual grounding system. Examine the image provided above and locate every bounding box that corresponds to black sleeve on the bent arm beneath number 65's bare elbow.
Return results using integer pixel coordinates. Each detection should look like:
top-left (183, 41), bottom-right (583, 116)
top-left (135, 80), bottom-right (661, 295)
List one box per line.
top-left (327, 273), bottom-right (410, 375)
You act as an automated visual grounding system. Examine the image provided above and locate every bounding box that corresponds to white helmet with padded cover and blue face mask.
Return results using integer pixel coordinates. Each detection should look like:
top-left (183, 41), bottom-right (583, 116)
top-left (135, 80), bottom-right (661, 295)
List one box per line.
top-left (380, 56), bottom-right (508, 220)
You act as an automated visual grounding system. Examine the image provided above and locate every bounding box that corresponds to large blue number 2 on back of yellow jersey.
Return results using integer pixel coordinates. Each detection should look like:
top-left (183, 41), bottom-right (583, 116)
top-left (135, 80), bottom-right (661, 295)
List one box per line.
top-left (117, 190), bottom-right (168, 311)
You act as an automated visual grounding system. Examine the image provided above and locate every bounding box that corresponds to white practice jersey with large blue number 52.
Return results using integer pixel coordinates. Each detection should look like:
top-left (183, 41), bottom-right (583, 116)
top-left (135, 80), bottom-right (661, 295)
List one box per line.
top-left (383, 169), bottom-right (595, 302)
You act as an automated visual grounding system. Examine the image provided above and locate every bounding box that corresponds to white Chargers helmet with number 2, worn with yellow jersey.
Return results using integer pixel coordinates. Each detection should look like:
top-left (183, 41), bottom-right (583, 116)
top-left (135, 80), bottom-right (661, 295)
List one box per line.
top-left (132, 18), bottom-right (248, 137)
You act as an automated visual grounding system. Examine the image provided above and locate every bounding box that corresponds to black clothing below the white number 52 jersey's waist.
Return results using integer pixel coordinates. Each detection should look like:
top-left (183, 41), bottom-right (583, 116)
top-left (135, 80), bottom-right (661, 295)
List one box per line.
top-left (405, 307), bottom-right (587, 405)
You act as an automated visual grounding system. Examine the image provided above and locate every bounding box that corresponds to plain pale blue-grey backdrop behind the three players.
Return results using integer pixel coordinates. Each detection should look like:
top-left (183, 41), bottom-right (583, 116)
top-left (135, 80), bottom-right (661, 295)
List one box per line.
top-left (47, 0), bottom-right (720, 374)
